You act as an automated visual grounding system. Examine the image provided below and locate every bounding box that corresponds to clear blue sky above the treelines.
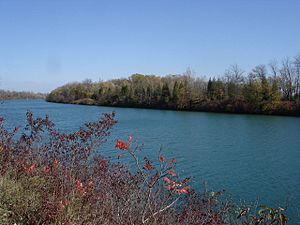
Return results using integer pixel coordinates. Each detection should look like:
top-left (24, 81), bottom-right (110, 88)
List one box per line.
top-left (0, 0), bottom-right (300, 93)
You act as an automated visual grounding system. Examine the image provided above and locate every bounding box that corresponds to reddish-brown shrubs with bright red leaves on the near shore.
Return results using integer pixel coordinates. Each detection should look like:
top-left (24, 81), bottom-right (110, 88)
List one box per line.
top-left (0, 112), bottom-right (286, 225)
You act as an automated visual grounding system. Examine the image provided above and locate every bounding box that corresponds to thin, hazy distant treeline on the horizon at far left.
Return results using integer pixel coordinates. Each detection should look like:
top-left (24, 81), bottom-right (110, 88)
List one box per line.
top-left (0, 90), bottom-right (46, 100)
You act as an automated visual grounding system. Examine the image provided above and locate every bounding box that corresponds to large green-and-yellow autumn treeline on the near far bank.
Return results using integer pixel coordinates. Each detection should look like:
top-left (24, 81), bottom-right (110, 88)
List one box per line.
top-left (47, 55), bottom-right (300, 115)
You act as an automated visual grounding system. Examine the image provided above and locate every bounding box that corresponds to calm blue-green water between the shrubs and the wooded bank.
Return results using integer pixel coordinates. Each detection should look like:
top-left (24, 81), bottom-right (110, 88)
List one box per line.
top-left (0, 100), bottom-right (300, 221)
